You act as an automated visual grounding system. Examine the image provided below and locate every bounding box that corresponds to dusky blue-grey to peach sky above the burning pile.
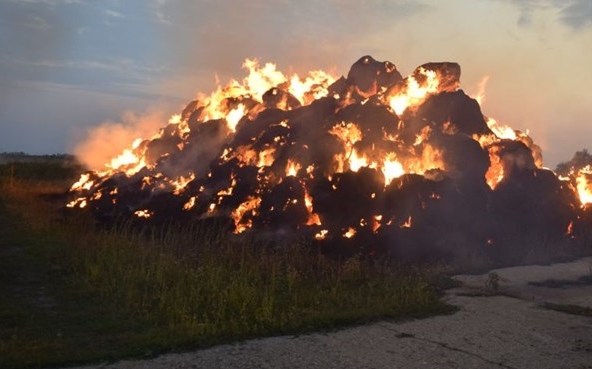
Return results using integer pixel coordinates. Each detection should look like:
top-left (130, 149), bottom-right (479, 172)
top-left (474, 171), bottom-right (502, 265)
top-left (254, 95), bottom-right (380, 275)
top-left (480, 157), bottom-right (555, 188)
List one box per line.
top-left (0, 0), bottom-right (592, 168)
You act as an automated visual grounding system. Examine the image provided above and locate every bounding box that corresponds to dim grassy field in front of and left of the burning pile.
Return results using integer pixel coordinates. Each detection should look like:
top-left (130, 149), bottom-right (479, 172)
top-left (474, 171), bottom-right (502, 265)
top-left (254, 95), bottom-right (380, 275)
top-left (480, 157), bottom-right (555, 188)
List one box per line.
top-left (0, 159), bottom-right (452, 368)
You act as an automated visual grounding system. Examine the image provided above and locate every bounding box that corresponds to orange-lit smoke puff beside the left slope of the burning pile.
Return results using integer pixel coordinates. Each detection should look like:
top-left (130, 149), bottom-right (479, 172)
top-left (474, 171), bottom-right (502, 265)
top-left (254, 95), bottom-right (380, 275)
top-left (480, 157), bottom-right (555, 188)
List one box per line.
top-left (73, 110), bottom-right (166, 170)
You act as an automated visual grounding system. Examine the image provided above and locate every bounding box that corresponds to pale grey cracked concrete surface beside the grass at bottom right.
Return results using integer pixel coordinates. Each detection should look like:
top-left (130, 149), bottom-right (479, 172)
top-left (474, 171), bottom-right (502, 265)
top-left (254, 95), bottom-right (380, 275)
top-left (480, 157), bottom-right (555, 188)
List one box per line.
top-left (67, 258), bottom-right (592, 369)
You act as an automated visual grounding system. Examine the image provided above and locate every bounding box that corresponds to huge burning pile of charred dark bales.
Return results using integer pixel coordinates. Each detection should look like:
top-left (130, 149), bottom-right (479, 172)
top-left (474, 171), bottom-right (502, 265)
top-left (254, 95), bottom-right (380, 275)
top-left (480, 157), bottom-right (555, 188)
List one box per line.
top-left (68, 56), bottom-right (592, 257)
